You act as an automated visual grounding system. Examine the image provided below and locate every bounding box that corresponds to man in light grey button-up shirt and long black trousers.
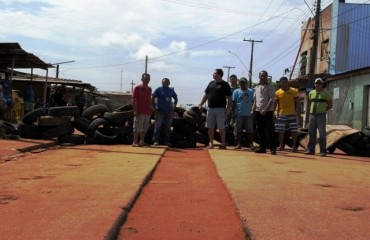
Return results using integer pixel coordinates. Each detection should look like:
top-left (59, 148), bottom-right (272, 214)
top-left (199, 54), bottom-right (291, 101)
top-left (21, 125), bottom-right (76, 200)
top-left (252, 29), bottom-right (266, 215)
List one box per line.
top-left (253, 70), bottom-right (276, 155)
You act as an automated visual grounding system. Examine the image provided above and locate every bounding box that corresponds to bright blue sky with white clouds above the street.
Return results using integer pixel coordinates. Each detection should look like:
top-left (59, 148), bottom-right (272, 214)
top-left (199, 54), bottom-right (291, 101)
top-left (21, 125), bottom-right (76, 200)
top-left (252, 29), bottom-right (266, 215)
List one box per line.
top-left (0, 0), bottom-right (370, 104)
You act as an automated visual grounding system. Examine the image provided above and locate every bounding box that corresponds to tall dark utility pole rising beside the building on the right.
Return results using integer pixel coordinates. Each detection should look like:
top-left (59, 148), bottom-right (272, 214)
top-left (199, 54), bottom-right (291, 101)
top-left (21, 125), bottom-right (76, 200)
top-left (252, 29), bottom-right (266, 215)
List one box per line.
top-left (305, 0), bottom-right (321, 126)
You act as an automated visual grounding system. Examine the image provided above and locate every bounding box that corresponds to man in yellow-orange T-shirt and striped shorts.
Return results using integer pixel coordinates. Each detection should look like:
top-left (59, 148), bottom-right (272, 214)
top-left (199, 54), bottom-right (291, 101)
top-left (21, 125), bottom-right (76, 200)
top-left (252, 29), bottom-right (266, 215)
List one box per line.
top-left (275, 77), bottom-right (301, 152)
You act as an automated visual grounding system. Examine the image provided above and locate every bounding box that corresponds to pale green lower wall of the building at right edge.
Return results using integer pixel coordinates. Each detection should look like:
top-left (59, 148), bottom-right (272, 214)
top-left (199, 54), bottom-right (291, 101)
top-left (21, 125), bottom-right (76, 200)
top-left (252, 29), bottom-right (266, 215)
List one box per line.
top-left (327, 74), bottom-right (370, 130)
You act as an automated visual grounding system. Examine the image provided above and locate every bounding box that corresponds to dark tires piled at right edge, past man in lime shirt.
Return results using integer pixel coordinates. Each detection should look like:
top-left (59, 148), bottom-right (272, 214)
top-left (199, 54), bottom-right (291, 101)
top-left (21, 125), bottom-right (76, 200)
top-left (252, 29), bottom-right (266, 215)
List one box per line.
top-left (328, 127), bottom-right (370, 157)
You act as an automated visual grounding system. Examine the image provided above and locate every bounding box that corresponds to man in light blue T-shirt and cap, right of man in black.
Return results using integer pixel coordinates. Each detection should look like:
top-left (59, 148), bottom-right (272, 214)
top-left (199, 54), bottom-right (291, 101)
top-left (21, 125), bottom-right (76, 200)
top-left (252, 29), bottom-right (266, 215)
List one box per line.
top-left (232, 77), bottom-right (254, 150)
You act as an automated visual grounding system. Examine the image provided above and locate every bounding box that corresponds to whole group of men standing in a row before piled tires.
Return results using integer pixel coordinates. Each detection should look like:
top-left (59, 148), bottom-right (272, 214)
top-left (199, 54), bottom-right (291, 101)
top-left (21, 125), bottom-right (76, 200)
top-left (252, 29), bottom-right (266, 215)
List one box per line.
top-left (132, 68), bottom-right (332, 156)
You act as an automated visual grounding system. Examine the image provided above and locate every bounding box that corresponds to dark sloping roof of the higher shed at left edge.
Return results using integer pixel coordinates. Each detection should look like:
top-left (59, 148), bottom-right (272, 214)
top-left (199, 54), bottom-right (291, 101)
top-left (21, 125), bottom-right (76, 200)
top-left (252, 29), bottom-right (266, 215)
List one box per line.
top-left (0, 43), bottom-right (54, 70)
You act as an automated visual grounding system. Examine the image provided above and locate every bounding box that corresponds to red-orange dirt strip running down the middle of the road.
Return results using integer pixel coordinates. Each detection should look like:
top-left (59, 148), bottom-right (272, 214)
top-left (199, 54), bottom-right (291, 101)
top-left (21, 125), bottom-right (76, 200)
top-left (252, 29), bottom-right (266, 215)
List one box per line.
top-left (119, 149), bottom-right (246, 240)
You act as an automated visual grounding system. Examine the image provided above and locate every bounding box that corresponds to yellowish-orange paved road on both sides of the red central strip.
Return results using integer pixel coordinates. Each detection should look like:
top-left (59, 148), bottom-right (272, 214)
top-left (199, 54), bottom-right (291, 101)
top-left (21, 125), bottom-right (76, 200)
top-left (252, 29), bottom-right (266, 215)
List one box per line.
top-left (0, 140), bottom-right (370, 239)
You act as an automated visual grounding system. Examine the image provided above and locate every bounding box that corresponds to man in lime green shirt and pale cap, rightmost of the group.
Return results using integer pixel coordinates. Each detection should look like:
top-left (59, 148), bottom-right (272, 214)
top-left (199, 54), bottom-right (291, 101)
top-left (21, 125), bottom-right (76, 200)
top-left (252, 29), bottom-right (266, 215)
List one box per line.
top-left (305, 78), bottom-right (333, 157)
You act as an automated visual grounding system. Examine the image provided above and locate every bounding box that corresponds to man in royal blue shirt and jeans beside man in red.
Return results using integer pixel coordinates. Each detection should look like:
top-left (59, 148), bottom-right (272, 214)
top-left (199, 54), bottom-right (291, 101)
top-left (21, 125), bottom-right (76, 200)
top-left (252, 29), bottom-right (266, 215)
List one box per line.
top-left (152, 78), bottom-right (177, 147)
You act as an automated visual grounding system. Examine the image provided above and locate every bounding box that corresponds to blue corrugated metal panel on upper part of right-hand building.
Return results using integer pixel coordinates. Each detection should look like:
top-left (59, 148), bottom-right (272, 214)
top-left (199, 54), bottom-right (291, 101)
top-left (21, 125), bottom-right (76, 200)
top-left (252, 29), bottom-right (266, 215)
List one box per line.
top-left (335, 3), bottom-right (370, 74)
